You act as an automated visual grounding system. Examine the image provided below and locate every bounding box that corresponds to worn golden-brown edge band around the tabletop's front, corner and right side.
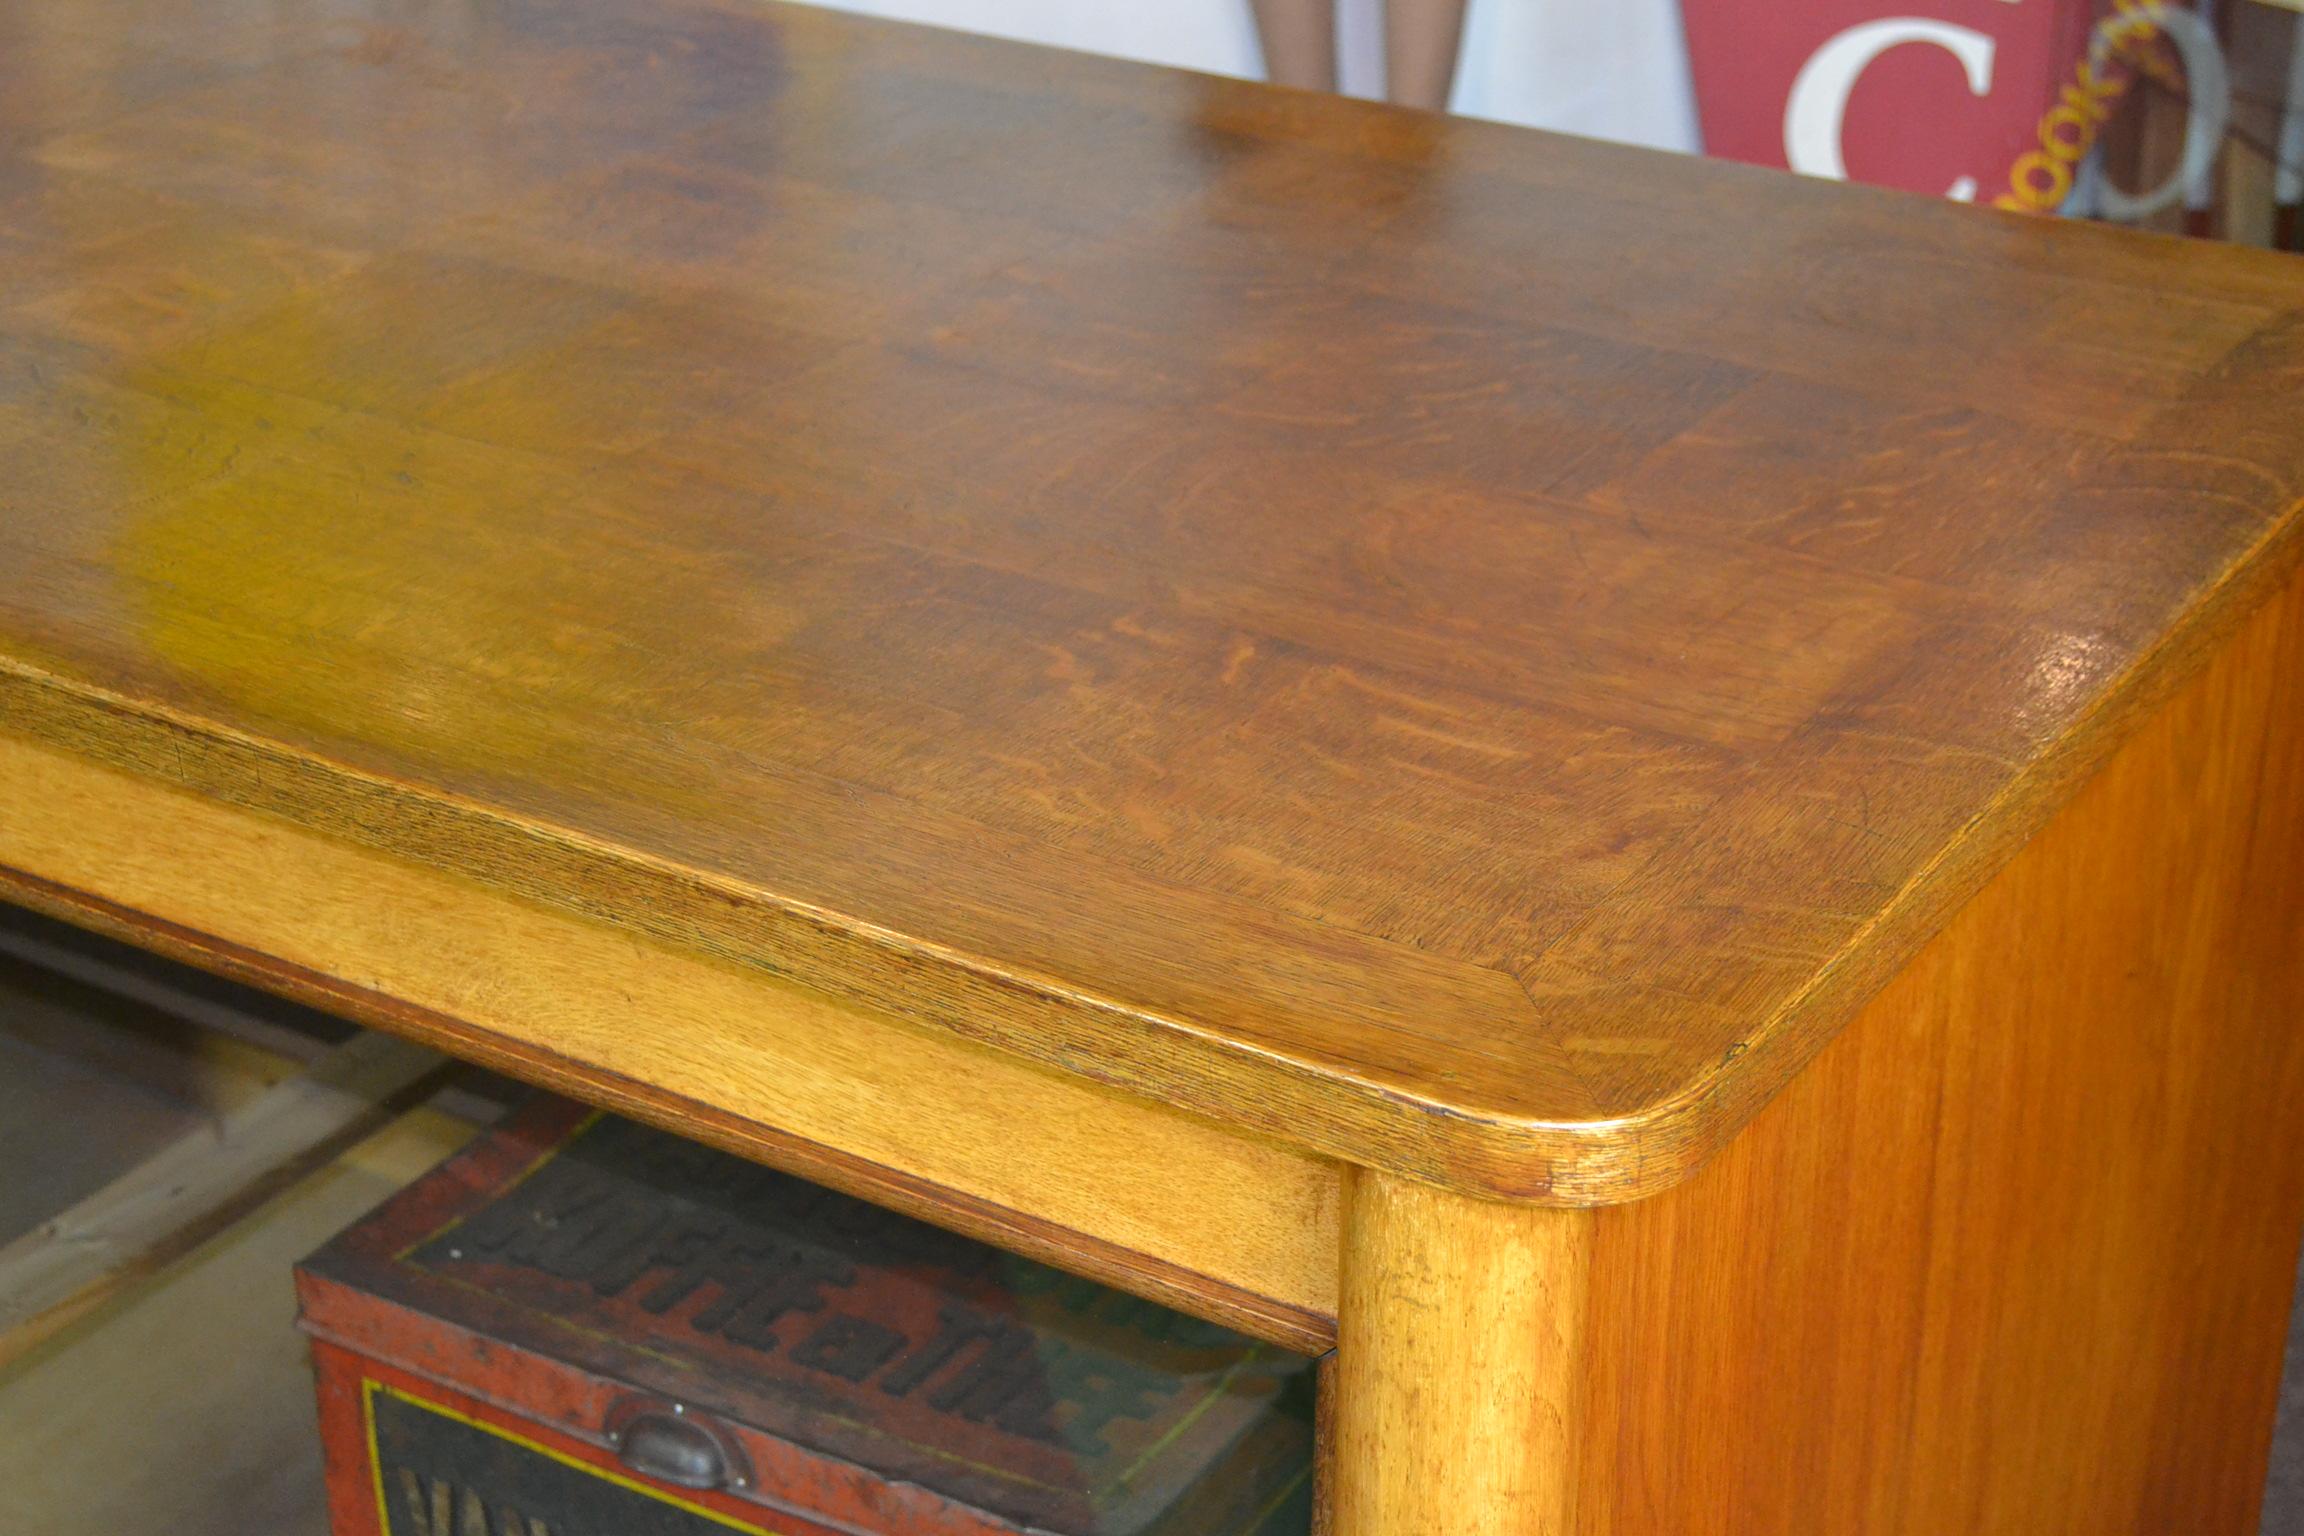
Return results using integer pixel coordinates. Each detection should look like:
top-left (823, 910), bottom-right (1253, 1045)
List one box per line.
top-left (0, 504), bottom-right (2304, 1215)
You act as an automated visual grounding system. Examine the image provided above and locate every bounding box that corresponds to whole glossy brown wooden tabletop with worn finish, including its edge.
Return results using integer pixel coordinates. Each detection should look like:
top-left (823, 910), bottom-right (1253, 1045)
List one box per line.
top-left (0, 0), bottom-right (2304, 1202)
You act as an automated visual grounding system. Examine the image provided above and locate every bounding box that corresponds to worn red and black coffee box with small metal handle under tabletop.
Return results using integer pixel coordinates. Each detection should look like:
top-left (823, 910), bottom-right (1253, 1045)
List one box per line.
top-left (297, 1098), bottom-right (1311, 1536)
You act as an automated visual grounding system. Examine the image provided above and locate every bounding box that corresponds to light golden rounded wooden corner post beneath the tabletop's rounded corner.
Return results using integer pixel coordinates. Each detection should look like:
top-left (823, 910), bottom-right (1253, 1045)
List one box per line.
top-left (1327, 1170), bottom-right (1592, 1536)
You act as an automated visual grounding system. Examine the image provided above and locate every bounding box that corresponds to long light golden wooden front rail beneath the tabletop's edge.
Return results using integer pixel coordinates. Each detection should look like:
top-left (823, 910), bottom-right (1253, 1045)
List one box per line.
top-left (0, 735), bottom-right (1339, 1349)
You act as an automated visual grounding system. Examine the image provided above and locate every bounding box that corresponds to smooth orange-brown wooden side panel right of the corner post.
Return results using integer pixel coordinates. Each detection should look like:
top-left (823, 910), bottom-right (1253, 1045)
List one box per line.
top-left (1583, 568), bottom-right (2304, 1536)
